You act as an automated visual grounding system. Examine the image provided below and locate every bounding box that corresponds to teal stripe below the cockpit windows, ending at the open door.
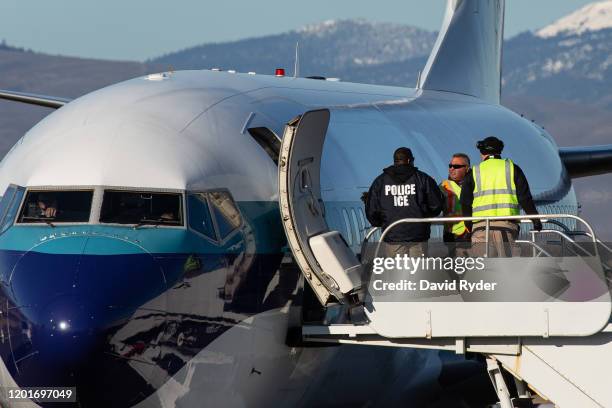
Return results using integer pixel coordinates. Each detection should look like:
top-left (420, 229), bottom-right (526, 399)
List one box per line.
top-left (0, 201), bottom-right (286, 255)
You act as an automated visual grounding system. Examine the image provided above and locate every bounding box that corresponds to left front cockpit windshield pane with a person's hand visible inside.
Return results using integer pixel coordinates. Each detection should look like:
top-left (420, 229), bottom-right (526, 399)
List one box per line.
top-left (17, 190), bottom-right (93, 223)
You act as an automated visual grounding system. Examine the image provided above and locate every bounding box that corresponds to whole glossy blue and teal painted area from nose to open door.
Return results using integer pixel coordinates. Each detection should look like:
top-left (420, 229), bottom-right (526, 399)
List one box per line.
top-left (0, 197), bottom-right (299, 406)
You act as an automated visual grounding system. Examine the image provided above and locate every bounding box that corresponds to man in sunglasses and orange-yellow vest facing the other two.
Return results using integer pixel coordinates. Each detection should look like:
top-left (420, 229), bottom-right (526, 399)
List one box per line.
top-left (440, 153), bottom-right (470, 242)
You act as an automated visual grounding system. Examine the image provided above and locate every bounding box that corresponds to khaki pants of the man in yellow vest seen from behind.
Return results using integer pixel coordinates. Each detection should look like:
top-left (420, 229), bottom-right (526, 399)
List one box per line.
top-left (472, 221), bottom-right (520, 258)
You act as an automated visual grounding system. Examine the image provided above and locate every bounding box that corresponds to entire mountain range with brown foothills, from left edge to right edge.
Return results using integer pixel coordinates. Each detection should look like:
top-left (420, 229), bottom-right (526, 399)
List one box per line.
top-left (0, 0), bottom-right (612, 238)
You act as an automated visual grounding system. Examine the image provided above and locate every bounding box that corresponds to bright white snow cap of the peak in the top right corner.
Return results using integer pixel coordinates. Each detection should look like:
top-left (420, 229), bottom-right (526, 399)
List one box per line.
top-left (536, 0), bottom-right (612, 38)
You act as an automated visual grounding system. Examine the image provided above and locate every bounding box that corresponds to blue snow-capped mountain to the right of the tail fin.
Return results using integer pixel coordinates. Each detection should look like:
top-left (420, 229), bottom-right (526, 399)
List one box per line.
top-left (504, 0), bottom-right (612, 109)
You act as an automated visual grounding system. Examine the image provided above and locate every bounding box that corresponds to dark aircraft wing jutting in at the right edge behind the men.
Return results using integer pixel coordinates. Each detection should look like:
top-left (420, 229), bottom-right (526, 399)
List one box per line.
top-left (559, 144), bottom-right (612, 178)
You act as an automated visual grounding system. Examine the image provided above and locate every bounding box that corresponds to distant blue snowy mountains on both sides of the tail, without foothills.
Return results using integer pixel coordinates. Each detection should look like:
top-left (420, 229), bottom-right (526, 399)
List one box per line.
top-left (149, 1), bottom-right (612, 108)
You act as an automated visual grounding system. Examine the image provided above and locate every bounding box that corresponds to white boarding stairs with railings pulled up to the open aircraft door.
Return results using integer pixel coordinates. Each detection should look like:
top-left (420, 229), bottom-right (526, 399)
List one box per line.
top-left (286, 214), bottom-right (612, 408)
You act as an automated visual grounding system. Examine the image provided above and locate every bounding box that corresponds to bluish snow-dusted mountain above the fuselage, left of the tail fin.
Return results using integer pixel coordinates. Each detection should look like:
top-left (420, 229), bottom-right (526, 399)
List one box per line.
top-left (151, 20), bottom-right (436, 79)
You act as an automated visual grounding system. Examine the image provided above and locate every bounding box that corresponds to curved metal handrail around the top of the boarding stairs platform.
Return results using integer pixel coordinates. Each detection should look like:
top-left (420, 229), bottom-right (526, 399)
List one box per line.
top-left (362, 214), bottom-right (610, 259)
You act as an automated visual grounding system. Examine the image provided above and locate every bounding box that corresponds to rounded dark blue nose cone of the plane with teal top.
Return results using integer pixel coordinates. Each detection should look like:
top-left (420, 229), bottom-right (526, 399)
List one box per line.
top-left (3, 236), bottom-right (170, 406)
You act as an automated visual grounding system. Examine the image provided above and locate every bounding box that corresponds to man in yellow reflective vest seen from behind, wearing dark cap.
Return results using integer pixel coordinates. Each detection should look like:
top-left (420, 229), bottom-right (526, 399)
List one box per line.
top-left (461, 136), bottom-right (542, 256)
